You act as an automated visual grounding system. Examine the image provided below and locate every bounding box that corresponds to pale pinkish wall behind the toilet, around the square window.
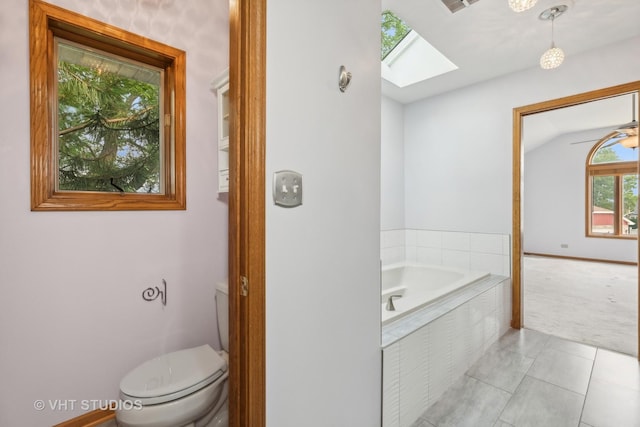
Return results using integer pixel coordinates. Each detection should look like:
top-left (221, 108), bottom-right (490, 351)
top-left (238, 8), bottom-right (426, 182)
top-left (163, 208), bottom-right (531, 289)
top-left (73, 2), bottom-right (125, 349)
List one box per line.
top-left (0, 0), bottom-right (230, 427)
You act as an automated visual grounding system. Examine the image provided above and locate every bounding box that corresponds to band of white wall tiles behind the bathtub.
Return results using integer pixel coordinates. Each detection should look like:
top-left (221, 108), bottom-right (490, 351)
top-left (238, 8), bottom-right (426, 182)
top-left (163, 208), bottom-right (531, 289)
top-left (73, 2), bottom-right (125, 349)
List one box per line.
top-left (380, 229), bottom-right (511, 276)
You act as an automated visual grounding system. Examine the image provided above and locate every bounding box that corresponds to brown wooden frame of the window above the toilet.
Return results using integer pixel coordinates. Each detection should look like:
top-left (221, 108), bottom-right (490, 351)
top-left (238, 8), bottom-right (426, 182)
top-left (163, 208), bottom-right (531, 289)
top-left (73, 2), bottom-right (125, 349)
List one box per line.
top-left (29, 0), bottom-right (186, 211)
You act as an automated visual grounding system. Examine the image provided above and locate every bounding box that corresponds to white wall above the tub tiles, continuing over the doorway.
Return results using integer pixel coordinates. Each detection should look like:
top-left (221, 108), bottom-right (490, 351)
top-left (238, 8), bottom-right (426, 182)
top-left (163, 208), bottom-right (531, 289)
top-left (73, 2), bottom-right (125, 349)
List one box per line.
top-left (404, 38), bottom-right (640, 239)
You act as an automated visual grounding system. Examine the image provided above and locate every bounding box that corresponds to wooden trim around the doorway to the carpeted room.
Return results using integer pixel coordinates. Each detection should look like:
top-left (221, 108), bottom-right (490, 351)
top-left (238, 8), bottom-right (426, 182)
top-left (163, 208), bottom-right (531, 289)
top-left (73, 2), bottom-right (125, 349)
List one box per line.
top-left (511, 81), bottom-right (640, 358)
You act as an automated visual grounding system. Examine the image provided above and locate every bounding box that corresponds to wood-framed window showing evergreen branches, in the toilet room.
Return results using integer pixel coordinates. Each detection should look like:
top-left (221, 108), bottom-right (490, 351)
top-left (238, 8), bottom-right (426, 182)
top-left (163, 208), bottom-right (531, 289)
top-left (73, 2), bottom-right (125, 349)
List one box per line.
top-left (29, 0), bottom-right (186, 210)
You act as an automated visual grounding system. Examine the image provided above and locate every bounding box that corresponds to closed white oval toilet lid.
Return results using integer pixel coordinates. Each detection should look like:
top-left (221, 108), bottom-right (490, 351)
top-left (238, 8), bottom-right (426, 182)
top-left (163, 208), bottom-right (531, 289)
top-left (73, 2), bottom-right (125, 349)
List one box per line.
top-left (120, 345), bottom-right (227, 403)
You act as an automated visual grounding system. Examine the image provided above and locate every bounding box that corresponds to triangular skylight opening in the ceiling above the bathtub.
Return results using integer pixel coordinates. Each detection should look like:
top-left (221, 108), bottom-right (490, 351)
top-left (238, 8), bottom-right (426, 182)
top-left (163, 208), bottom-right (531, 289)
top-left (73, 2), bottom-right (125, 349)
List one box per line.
top-left (381, 10), bottom-right (458, 87)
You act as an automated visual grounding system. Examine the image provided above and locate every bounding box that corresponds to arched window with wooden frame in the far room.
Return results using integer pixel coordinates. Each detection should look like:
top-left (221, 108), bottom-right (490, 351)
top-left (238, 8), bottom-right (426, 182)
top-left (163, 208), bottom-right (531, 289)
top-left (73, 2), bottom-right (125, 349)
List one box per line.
top-left (586, 132), bottom-right (638, 239)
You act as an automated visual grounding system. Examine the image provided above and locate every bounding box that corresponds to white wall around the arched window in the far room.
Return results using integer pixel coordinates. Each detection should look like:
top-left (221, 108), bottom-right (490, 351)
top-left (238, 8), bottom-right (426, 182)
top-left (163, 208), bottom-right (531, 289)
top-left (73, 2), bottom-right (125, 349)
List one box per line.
top-left (523, 127), bottom-right (638, 262)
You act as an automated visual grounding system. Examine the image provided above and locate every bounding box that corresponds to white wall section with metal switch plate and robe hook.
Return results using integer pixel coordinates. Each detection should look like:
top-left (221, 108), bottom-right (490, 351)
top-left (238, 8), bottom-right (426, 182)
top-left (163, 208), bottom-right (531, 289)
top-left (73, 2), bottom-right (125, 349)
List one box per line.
top-left (265, 0), bottom-right (381, 427)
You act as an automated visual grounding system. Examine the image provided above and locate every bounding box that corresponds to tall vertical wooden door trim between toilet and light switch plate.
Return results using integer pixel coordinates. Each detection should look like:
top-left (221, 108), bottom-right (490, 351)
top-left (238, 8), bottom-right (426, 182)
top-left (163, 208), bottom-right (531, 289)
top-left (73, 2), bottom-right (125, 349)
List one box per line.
top-left (229, 0), bottom-right (267, 427)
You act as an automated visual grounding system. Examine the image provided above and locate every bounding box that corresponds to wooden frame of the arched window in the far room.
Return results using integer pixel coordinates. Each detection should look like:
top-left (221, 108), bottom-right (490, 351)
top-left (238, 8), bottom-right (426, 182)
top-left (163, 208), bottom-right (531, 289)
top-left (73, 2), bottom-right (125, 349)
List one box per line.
top-left (584, 140), bottom-right (638, 240)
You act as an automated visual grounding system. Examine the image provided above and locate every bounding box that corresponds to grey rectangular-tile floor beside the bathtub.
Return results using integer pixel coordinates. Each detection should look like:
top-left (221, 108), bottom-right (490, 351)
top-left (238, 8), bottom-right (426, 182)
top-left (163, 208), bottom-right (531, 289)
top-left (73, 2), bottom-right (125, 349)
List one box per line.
top-left (412, 329), bottom-right (640, 427)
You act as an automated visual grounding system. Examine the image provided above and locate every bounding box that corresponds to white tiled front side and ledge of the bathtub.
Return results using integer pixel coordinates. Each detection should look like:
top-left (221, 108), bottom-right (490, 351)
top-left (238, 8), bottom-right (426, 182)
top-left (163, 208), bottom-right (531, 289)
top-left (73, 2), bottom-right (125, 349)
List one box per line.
top-left (382, 275), bottom-right (511, 427)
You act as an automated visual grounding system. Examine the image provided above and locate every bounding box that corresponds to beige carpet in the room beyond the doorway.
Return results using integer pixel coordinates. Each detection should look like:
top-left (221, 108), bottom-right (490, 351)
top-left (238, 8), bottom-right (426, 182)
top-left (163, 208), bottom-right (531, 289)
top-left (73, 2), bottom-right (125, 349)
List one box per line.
top-left (524, 256), bottom-right (638, 356)
